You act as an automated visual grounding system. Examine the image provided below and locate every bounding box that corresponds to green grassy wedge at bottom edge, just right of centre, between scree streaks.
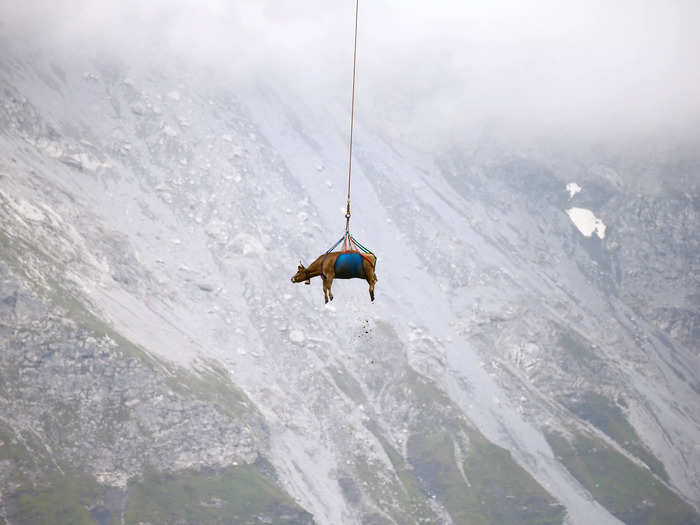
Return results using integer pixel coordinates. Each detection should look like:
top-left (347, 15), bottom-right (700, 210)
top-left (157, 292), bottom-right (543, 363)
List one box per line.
top-left (400, 369), bottom-right (565, 525)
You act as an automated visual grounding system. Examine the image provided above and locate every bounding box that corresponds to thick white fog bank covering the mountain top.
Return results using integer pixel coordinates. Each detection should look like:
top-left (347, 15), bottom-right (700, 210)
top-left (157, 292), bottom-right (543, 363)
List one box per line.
top-left (0, 0), bottom-right (700, 147)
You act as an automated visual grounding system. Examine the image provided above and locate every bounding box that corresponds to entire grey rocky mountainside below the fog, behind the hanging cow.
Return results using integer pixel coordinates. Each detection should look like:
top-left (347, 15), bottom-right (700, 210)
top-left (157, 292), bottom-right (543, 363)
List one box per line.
top-left (0, 32), bottom-right (700, 524)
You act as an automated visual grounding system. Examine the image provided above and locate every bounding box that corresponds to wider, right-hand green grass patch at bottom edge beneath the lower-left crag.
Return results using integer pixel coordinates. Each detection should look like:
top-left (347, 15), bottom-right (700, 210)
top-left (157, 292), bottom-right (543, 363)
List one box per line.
top-left (125, 465), bottom-right (311, 524)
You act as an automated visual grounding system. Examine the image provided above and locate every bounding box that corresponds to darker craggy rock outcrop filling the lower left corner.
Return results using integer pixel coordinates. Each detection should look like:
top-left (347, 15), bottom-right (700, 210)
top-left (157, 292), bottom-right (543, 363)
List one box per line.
top-left (0, 253), bottom-right (310, 523)
